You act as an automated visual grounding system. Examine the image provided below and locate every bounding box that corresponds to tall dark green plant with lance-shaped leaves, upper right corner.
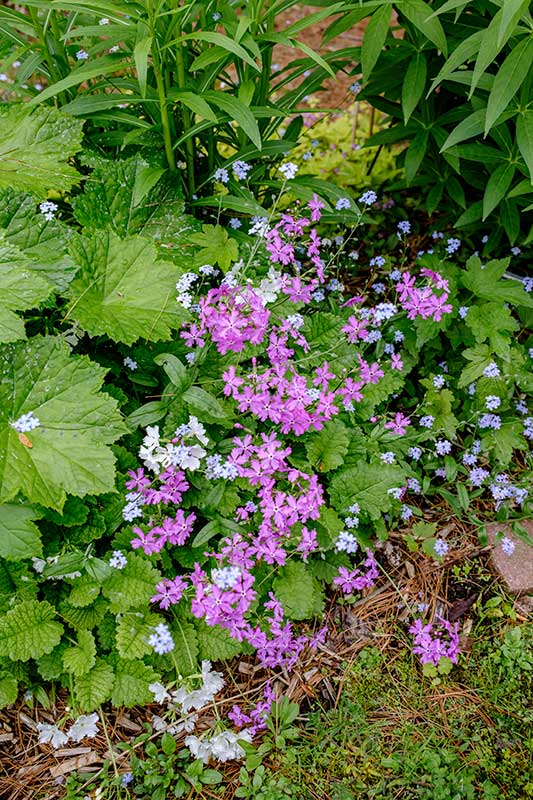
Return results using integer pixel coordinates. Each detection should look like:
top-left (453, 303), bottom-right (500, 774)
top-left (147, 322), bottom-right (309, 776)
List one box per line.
top-left (326, 0), bottom-right (533, 243)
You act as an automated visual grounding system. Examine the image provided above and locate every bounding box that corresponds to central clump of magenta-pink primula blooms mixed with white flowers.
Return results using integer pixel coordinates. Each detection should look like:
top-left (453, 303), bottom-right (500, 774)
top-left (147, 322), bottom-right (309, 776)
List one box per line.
top-left (124, 196), bottom-right (480, 688)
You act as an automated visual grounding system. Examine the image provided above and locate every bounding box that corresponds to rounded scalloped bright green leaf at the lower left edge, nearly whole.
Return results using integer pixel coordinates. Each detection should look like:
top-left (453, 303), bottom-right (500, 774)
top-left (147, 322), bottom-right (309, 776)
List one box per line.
top-left (0, 600), bottom-right (63, 661)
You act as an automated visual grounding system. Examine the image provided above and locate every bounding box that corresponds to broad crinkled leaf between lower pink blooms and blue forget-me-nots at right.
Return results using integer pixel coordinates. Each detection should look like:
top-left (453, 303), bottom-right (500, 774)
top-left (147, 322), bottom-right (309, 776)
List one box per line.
top-left (329, 461), bottom-right (406, 519)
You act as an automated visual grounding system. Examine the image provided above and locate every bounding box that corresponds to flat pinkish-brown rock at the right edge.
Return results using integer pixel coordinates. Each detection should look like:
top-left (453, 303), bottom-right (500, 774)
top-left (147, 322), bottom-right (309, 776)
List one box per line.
top-left (487, 520), bottom-right (533, 594)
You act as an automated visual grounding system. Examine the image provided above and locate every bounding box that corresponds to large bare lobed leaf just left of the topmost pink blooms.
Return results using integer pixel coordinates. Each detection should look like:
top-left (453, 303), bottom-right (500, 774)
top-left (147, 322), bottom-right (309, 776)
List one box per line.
top-left (67, 231), bottom-right (186, 344)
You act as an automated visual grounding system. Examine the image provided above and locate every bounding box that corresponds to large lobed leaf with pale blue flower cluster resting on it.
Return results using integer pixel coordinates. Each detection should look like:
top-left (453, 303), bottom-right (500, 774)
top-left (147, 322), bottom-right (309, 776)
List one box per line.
top-left (0, 336), bottom-right (127, 511)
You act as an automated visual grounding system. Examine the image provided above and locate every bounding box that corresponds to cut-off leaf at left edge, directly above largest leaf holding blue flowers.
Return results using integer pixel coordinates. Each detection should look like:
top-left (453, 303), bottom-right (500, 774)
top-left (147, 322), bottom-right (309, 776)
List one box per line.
top-left (0, 238), bottom-right (53, 342)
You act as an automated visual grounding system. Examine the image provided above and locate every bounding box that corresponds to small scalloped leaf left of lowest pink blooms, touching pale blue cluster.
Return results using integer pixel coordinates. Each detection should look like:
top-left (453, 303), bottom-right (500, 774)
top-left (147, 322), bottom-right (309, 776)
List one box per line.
top-left (102, 554), bottom-right (161, 614)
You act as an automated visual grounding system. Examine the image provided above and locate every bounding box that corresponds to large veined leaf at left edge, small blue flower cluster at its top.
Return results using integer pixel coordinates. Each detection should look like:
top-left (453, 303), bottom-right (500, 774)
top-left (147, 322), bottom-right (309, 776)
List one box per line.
top-left (0, 188), bottom-right (77, 291)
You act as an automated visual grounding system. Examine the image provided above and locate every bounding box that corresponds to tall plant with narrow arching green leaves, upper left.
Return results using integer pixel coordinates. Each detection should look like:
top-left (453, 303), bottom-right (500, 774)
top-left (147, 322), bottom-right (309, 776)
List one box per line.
top-left (0, 0), bottom-right (348, 198)
